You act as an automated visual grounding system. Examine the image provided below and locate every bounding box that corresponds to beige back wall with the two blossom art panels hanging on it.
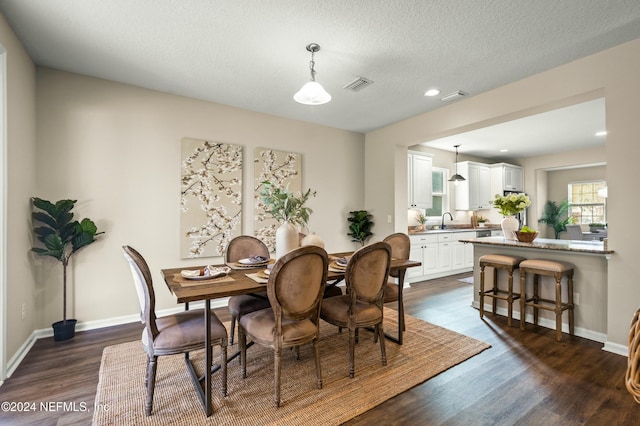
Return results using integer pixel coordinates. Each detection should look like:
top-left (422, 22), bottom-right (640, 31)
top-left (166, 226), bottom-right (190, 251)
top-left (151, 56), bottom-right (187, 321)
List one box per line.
top-left (36, 68), bottom-right (364, 327)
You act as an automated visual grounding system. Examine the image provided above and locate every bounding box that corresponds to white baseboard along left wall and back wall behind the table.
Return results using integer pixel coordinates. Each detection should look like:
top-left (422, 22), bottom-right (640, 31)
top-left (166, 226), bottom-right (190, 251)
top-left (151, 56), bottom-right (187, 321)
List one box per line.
top-left (0, 298), bottom-right (229, 386)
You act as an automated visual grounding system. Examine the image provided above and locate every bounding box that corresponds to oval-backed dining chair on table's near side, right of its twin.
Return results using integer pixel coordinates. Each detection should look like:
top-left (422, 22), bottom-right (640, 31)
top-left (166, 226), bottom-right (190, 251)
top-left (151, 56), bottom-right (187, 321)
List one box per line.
top-left (320, 242), bottom-right (391, 378)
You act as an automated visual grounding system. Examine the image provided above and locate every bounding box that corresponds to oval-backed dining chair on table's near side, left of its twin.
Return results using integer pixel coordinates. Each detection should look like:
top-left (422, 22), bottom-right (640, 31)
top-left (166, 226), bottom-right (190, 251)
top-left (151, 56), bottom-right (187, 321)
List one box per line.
top-left (238, 246), bottom-right (329, 407)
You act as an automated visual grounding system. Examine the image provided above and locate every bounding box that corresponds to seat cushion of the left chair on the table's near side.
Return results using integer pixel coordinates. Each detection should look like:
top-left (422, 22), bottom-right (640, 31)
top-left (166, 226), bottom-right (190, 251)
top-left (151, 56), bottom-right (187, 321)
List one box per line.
top-left (240, 308), bottom-right (317, 342)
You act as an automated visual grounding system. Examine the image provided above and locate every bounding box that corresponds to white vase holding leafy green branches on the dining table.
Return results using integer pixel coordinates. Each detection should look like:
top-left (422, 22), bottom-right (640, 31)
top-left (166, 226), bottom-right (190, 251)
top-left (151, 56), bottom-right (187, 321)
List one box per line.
top-left (260, 181), bottom-right (316, 259)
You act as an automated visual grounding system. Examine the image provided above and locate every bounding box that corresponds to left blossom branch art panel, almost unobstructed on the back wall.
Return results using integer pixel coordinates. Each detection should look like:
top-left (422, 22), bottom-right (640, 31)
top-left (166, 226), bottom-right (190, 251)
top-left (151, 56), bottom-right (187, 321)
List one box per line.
top-left (180, 138), bottom-right (242, 259)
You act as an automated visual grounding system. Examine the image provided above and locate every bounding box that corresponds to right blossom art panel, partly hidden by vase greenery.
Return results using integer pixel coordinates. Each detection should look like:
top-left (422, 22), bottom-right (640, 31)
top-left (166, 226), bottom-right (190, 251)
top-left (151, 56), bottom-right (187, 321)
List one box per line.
top-left (253, 148), bottom-right (302, 252)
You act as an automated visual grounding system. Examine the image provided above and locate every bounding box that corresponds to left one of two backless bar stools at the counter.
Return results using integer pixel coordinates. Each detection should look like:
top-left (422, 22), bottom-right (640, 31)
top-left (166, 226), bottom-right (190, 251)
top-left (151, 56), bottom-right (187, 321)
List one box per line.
top-left (478, 254), bottom-right (525, 327)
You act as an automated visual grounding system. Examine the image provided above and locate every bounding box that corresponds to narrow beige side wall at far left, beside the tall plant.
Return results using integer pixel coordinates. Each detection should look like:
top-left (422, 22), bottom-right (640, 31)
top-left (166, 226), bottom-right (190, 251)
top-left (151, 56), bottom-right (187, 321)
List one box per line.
top-left (0, 15), bottom-right (38, 370)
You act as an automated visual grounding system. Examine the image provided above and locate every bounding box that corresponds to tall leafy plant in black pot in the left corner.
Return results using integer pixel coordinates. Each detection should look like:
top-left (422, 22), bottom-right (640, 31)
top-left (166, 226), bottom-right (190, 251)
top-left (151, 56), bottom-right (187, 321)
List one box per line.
top-left (31, 198), bottom-right (104, 341)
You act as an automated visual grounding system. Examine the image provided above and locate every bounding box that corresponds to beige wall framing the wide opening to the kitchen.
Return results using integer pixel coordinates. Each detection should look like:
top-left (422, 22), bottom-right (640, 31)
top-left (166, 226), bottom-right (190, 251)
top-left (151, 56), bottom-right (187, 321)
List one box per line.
top-left (365, 40), bottom-right (640, 347)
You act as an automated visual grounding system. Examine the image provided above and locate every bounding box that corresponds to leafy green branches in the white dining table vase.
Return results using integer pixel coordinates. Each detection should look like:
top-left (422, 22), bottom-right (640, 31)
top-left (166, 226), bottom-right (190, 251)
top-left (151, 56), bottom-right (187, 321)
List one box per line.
top-left (259, 181), bottom-right (316, 227)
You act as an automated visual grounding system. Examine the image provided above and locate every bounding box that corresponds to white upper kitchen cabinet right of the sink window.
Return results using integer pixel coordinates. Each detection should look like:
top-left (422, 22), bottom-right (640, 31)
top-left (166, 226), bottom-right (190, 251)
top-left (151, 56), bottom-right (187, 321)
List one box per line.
top-left (455, 161), bottom-right (493, 210)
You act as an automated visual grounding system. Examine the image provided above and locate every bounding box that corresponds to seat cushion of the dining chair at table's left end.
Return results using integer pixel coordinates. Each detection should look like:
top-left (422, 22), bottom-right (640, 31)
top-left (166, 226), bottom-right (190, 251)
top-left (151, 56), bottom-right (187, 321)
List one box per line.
top-left (142, 309), bottom-right (227, 355)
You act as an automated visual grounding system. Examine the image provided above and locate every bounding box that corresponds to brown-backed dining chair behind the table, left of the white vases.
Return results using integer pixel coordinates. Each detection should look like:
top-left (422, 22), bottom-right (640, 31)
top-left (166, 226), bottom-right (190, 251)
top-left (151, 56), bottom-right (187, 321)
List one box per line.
top-left (224, 235), bottom-right (271, 344)
